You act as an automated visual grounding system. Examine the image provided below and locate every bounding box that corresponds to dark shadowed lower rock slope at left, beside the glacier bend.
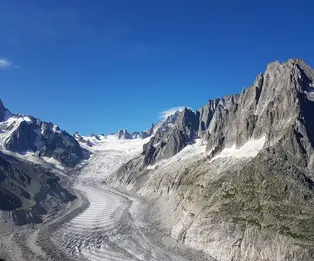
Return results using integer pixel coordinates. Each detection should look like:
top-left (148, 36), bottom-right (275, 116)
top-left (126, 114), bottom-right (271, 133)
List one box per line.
top-left (0, 154), bottom-right (76, 225)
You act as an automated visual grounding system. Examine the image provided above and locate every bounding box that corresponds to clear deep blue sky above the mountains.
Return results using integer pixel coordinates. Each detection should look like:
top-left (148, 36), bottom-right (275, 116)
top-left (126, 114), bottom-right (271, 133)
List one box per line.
top-left (0, 0), bottom-right (314, 134)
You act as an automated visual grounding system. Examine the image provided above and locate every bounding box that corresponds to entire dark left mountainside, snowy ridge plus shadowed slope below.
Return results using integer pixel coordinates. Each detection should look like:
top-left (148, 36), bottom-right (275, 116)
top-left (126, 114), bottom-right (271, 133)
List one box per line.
top-left (0, 101), bottom-right (84, 228)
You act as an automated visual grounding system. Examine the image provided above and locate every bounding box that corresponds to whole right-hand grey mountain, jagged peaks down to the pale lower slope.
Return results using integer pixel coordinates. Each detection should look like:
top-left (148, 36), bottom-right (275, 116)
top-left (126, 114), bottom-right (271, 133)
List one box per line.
top-left (107, 59), bottom-right (314, 261)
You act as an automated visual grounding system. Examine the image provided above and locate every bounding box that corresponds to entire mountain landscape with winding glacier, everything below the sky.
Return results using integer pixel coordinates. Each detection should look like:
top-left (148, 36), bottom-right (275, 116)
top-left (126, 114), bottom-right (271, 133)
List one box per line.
top-left (0, 59), bottom-right (314, 261)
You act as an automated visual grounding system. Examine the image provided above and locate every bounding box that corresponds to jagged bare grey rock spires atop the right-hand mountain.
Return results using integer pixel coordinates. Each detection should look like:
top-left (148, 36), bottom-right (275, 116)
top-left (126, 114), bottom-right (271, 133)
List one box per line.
top-left (143, 59), bottom-right (314, 170)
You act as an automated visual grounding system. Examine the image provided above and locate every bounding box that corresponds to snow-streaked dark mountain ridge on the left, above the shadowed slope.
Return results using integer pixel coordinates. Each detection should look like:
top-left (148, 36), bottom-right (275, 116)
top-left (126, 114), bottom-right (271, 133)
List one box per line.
top-left (0, 101), bottom-right (84, 167)
